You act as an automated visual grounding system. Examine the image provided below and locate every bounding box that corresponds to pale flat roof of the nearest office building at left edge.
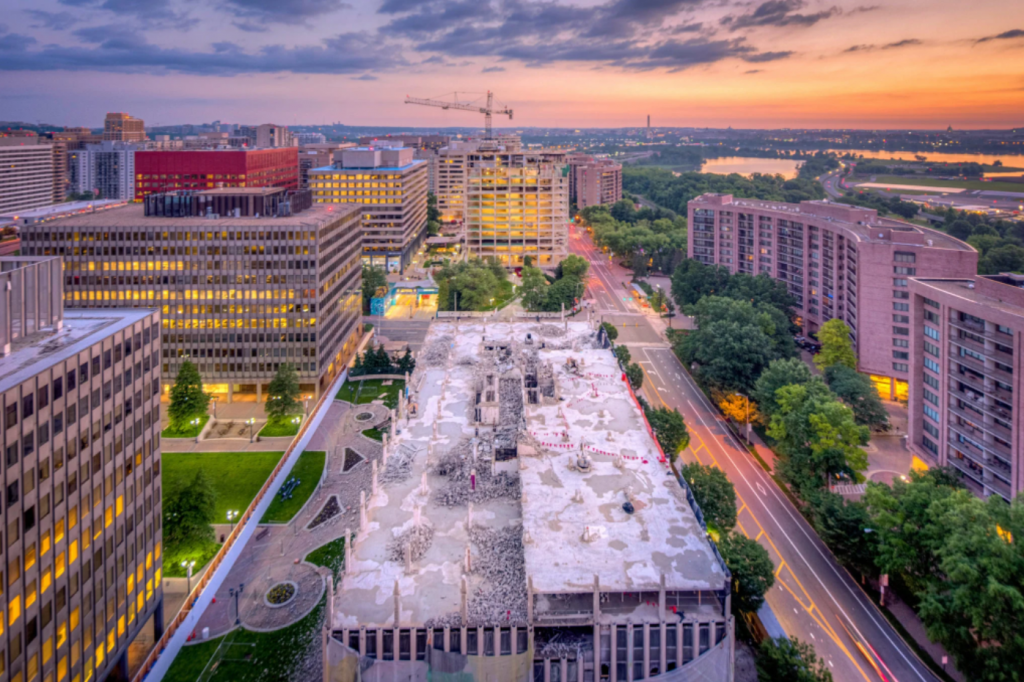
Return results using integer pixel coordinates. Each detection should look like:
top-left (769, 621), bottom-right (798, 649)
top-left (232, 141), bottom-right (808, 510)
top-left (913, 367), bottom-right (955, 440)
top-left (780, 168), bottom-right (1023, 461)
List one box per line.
top-left (0, 308), bottom-right (154, 392)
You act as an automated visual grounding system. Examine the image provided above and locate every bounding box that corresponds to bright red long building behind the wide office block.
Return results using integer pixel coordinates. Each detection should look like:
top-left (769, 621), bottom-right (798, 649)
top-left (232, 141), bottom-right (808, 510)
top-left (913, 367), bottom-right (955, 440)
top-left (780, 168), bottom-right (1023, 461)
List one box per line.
top-left (135, 146), bottom-right (299, 200)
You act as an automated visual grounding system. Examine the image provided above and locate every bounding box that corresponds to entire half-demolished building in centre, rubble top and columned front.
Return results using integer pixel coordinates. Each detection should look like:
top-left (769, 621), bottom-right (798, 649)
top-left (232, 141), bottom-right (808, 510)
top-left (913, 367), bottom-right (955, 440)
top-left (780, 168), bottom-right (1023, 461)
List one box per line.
top-left (325, 316), bottom-right (734, 682)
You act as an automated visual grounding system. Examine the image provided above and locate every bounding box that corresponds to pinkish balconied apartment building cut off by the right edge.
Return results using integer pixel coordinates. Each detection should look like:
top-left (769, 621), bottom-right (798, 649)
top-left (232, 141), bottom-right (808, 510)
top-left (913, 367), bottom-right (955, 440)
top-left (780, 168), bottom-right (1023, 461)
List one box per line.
top-left (907, 274), bottom-right (1024, 502)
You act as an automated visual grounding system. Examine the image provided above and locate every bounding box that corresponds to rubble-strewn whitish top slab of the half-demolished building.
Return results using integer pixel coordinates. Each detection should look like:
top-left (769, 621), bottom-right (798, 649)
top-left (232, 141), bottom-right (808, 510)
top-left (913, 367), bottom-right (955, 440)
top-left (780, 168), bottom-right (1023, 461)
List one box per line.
top-left (333, 319), bottom-right (728, 629)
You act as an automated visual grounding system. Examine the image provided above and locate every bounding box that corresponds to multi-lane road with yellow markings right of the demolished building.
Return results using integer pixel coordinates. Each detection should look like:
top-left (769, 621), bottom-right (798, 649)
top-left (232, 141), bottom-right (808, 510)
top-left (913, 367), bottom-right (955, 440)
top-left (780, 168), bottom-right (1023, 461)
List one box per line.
top-left (569, 227), bottom-right (937, 682)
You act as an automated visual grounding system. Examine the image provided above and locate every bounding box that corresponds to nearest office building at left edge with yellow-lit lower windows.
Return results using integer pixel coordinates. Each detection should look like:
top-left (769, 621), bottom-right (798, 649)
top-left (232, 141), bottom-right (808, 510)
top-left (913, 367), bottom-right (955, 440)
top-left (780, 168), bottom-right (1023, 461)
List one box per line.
top-left (0, 251), bottom-right (164, 682)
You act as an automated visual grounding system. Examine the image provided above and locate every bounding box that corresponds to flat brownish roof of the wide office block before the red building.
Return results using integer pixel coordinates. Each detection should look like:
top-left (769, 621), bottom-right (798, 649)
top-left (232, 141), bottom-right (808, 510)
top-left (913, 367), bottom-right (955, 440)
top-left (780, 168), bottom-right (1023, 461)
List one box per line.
top-left (35, 201), bottom-right (359, 228)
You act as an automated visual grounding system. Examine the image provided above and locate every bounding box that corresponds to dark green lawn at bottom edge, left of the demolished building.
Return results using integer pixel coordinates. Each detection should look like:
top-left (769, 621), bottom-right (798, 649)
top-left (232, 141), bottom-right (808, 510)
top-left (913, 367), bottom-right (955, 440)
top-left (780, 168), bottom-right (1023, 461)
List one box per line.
top-left (164, 586), bottom-right (327, 682)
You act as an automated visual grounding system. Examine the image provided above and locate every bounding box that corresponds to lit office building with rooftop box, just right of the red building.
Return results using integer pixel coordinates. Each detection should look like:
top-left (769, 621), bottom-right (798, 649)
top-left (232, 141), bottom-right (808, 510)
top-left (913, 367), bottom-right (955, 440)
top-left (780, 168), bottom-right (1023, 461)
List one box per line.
top-left (309, 147), bottom-right (427, 272)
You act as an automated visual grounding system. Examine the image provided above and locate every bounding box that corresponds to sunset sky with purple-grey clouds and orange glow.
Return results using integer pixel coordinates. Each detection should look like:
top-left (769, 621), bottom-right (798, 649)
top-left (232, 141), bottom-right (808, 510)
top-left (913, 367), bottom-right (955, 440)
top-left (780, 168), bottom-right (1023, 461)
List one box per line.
top-left (0, 0), bottom-right (1024, 129)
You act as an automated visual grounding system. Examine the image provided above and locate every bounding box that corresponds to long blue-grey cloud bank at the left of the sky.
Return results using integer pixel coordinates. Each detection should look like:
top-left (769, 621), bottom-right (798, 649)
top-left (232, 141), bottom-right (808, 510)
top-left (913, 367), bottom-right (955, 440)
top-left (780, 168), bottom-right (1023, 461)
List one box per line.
top-left (0, 27), bottom-right (404, 76)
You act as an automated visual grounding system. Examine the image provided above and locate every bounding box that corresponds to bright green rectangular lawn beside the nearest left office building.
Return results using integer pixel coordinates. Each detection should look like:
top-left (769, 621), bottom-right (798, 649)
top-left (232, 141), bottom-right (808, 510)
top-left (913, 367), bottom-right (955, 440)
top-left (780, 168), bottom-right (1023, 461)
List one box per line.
top-left (161, 452), bottom-right (284, 523)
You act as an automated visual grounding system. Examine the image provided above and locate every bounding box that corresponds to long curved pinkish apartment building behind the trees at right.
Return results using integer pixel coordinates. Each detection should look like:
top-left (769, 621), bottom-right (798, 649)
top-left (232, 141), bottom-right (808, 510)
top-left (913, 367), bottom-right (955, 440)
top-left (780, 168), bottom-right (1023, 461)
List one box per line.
top-left (688, 195), bottom-right (978, 398)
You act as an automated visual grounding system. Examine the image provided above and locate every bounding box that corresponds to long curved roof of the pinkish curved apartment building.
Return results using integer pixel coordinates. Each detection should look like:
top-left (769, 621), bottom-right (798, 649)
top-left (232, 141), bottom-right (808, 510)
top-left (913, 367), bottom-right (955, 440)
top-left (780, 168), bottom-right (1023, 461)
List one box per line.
top-left (691, 193), bottom-right (975, 251)
